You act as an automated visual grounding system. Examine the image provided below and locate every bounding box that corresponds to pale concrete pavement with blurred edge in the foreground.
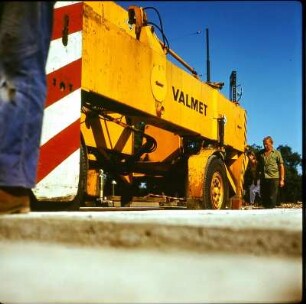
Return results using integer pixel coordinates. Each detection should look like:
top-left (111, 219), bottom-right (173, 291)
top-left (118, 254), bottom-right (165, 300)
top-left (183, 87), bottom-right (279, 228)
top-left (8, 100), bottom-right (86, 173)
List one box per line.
top-left (0, 209), bottom-right (302, 303)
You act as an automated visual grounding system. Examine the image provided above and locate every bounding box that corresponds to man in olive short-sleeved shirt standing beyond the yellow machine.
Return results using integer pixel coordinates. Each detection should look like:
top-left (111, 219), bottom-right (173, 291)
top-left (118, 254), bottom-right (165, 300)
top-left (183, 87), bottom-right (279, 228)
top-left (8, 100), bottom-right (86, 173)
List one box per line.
top-left (258, 136), bottom-right (285, 208)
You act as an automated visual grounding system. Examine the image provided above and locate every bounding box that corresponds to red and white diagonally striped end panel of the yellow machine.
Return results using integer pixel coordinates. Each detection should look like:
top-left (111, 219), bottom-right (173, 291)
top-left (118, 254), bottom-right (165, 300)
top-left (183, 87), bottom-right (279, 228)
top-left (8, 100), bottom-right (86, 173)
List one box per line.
top-left (33, 1), bottom-right (83, 201)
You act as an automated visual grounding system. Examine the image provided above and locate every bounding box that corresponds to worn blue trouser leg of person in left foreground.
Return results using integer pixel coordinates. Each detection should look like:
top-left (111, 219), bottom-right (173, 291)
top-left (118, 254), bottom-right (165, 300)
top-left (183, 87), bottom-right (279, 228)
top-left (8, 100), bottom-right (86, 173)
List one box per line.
top-left (0, 1), bottom-right (54, 188)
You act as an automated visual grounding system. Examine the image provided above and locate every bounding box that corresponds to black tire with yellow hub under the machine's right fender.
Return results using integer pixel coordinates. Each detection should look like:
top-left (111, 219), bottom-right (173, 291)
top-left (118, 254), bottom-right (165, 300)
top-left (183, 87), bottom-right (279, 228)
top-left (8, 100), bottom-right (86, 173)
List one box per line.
top-left (203, 155), bottom-right (229, 209)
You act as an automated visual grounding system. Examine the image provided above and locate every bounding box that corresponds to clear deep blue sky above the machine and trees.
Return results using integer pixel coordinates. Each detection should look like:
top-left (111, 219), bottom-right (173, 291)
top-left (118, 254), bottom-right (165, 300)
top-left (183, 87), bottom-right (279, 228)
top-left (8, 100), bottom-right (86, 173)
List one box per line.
top-left (116, 1), bottom-right (303, 160)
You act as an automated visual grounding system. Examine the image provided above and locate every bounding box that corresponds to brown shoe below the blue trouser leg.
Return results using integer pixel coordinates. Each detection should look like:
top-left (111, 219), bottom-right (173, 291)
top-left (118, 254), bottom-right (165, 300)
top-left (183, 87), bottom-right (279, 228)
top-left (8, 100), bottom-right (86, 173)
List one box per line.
top-left (0, 187), bottom-right (31, 214)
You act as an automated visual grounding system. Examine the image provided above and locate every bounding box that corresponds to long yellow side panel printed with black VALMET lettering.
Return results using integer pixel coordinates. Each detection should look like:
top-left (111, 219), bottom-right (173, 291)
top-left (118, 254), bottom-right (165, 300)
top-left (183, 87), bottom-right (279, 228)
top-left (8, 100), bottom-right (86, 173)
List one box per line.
top-left (82, 1), bottom-right (246, 151)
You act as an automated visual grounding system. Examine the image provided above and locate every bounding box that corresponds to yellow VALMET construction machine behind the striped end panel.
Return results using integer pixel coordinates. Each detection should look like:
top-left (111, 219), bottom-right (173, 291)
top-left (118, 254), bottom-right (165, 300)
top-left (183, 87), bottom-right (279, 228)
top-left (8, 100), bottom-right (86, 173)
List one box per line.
top-left (48, 1), bottom-right (247, 209)
